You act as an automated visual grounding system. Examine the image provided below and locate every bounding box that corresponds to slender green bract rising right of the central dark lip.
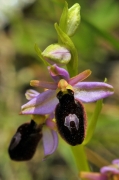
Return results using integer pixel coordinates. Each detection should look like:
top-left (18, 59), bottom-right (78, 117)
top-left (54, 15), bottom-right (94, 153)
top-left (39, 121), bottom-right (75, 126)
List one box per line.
top-left (83, 99), bottom-right (103, 145)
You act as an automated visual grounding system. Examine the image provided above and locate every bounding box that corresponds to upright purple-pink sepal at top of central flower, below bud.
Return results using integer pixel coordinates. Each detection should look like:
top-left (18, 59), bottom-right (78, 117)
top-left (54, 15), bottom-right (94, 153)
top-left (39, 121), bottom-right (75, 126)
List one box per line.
top-left (48, 64), bottom-right (69, 82)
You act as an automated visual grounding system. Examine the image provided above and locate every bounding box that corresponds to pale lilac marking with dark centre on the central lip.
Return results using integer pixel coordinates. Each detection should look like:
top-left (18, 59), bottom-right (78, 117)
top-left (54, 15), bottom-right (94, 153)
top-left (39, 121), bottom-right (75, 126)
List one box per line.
top-left (64, 114), bottom-right (79, 131)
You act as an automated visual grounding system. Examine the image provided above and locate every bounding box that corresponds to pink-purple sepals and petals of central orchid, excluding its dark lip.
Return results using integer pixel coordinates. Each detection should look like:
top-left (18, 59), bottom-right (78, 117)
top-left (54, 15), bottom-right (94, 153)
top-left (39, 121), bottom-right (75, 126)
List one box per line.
top-left (21, 64), bottom-right (114, 115)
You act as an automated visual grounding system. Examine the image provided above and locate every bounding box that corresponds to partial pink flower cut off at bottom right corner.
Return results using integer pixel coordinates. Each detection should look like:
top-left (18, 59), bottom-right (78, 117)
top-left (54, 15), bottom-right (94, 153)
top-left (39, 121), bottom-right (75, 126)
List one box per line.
top-left (80, 159), bottom-right (119, 180)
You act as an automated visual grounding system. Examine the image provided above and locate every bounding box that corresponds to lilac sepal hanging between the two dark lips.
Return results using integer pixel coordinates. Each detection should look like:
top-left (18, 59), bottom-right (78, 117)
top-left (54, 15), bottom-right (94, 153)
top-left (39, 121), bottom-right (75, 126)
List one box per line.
top-left (43, 127), bottom-right (58, 157)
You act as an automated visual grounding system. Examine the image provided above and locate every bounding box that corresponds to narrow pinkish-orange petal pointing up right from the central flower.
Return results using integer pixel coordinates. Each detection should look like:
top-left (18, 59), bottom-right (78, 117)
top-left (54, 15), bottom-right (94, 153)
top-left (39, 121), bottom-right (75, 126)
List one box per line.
top-left (69, 69), bottom-right (91, 86)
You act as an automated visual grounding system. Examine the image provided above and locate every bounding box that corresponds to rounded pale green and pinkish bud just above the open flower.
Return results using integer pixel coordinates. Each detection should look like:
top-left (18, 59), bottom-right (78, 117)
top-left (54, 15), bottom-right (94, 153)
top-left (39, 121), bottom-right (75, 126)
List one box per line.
top-left (42, 44), bottom-right (71, 65)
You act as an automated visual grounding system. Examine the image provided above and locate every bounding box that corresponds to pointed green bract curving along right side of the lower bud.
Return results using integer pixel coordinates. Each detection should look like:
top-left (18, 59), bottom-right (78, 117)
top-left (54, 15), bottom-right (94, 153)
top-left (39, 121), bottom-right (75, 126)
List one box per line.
top-left (55, 23), bottom-right (78, 77)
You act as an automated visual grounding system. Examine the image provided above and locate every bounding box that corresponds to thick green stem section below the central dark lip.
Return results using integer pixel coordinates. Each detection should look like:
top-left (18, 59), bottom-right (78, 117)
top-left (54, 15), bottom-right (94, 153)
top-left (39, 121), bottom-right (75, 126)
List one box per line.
top-left (71, 145), bottom-right (90, 172)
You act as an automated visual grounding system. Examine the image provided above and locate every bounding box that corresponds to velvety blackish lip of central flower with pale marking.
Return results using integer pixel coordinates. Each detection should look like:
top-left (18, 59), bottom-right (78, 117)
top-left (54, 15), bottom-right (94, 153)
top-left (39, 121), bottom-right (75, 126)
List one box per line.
top-left (55, 89), bottom-right (86, 146)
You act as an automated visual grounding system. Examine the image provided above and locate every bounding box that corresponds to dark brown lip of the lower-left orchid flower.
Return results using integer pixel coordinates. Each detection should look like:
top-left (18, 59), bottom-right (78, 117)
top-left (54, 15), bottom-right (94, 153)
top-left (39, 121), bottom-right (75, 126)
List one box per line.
top-left (8, 120), bottom-right (42, 161)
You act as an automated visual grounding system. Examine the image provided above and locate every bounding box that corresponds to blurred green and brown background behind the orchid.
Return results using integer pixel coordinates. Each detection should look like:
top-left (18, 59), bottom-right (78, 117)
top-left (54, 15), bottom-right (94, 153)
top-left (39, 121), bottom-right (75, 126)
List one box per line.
top-left (0, 0), bottom-right (119, 180)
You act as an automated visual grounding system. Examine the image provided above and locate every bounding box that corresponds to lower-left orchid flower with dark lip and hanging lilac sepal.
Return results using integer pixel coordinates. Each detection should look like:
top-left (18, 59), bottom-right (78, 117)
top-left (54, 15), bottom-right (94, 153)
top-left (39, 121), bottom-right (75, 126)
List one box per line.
top-left (8, 112), bottom-right (58, 161)
